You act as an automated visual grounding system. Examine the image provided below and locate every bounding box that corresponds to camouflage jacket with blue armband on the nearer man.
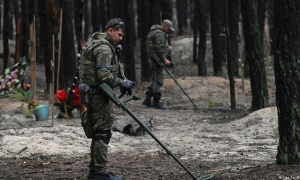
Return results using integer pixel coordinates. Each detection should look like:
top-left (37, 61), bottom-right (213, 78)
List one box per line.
top-left (79, 33), bottom-right (125, 87)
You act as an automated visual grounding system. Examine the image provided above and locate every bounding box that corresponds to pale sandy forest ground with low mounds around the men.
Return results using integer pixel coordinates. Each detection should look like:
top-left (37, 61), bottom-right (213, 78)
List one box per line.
top-left (0, 37), bottom-right (286, 179)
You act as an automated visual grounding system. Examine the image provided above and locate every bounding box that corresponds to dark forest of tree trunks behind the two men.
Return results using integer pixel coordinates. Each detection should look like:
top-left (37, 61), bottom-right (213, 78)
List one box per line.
top-left (0, 0), bottom-right (300, 168)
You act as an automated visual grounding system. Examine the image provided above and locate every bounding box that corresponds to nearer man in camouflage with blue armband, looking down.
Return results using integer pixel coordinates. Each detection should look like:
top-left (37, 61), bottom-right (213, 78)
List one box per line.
top-left (79, 18), bottom-right (135, 180)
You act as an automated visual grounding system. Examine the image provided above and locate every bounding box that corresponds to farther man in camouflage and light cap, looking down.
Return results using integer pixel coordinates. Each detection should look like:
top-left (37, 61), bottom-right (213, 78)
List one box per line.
top-left (143, 19), bottom-right (175, 109)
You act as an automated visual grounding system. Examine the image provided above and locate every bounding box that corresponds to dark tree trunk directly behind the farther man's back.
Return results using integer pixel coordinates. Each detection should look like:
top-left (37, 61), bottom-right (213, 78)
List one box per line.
top-left (139, 1), bottom-right (151, 81)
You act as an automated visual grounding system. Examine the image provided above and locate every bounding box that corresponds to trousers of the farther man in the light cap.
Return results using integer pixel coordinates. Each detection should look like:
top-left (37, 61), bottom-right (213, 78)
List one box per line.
top-left (148, 63), bottom-right (164, 93)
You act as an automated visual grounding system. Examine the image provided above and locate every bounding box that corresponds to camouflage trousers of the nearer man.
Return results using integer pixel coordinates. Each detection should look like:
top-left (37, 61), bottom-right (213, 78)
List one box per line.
top-left (87, 94), bottom-right (114, 174)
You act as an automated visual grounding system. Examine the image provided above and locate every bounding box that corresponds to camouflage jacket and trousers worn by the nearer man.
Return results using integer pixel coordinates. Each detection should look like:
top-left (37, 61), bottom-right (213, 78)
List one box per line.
top-left (79, 33), bottom-right (123, 174)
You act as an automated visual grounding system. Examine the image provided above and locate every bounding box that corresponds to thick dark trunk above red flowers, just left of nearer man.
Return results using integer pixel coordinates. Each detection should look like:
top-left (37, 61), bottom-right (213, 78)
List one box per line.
top-left (58, 0), bottom-right (77, 89)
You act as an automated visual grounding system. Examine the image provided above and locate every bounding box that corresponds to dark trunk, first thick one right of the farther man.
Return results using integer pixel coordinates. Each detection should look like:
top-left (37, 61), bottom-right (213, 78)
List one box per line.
top-left (195, 0), bottom-right (207, 76)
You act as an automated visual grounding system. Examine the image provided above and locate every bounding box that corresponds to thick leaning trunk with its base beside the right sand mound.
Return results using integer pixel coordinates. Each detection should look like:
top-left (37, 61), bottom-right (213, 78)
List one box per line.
top-left (241, 0), bottom-right (269, 110)
